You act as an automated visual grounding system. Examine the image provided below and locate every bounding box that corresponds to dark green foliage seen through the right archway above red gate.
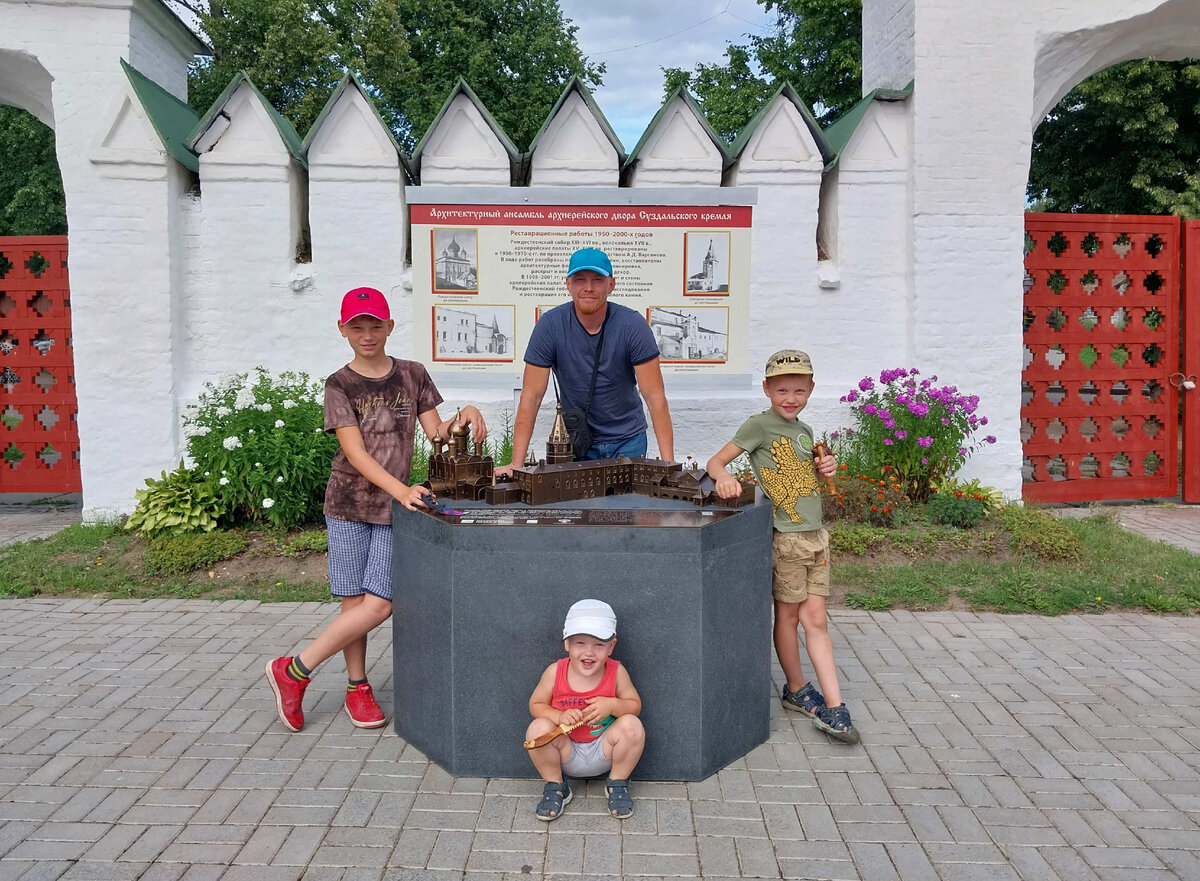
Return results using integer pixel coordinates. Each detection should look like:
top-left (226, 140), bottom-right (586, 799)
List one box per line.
top-left (1027, 59), bottom-right (1200, 218)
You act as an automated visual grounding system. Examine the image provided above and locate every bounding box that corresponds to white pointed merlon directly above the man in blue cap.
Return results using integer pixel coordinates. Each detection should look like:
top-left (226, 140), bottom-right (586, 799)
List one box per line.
top-left (529, 90), bottom-right (622, 186)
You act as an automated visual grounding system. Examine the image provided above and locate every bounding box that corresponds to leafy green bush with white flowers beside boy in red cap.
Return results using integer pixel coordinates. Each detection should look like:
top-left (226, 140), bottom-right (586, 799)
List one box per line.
top-left (184, 367), bottom-right (337, 529)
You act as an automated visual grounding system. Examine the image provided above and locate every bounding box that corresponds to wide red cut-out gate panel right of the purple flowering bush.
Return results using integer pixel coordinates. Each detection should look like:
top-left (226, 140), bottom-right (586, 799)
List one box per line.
top-left (1021, 214), bottom-right (1180, 502)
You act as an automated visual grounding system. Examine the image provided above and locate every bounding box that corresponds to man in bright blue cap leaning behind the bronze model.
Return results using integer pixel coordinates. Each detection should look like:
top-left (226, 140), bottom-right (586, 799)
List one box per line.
top-left (496, 247), bottom-right (674, 478)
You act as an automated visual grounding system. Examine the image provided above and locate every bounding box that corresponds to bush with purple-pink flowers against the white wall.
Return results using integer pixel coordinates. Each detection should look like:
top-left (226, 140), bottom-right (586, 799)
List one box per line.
top-left (830, 367), bottom-right (996, 501)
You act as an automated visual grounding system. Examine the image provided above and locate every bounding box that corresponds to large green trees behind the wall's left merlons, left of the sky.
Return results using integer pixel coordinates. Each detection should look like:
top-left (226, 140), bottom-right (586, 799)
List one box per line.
top-left (188, 0), bottom-right (604, 149)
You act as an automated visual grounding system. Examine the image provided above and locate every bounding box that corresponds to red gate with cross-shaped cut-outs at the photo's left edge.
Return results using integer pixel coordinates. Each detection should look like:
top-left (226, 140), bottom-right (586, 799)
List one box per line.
top-left (0, 235), bottom-right (79, 493)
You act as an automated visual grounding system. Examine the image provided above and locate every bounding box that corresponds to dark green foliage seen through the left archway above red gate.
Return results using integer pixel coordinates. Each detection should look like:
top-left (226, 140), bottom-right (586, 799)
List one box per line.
top-left (0, 106), bottom-right (67, 235)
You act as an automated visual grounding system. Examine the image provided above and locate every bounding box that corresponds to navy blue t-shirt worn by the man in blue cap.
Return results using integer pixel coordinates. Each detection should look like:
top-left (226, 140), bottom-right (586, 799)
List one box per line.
top-left (524, 301), bottom-right (659, 443)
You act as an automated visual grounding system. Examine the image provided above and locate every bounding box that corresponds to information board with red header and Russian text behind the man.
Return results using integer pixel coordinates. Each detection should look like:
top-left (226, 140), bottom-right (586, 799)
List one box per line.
top-left (410, 204), bottom-right (751, 374)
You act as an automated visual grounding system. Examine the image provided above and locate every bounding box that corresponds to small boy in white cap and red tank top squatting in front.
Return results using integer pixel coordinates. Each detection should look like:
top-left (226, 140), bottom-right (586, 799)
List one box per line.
top-left (526, 599), bottom-right (646, 822)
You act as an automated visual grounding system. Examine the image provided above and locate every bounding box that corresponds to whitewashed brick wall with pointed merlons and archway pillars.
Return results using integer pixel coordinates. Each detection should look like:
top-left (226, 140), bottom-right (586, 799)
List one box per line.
top-left (9, 0), bottom-right (1200, 516)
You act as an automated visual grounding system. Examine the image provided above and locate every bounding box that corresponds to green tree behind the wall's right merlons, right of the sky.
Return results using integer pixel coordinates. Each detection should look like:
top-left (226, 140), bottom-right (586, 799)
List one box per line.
top-left (664, 0), bottom-right (863, 140)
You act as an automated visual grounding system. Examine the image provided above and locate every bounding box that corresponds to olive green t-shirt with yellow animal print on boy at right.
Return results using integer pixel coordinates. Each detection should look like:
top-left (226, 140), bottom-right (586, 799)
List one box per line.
top-left (733, 409), bottom-right (821, 532)
